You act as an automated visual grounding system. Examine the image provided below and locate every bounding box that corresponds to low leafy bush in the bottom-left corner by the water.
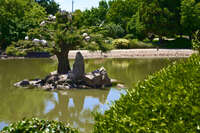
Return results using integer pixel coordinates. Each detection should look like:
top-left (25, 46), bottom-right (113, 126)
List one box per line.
top-left (1, 118), bottom-right (79, 133)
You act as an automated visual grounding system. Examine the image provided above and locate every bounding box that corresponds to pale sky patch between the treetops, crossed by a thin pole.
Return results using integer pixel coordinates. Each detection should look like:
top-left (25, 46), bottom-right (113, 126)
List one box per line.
top-left (55, 0), bottom-right (100, 11)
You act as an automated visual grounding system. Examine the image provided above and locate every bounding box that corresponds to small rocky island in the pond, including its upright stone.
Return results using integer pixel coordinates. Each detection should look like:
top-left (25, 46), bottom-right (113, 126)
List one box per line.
top-left (14, 52), bottom-right (115, 91)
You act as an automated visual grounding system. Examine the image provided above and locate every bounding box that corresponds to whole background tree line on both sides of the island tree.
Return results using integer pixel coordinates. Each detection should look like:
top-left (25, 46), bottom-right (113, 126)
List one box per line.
top-left (0, 0), bottom-right (200, 49)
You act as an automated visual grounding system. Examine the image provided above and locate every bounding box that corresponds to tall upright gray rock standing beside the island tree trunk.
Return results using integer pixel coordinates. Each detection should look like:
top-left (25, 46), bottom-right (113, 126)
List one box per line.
top-left (72, 52), bottom-right (85, 81)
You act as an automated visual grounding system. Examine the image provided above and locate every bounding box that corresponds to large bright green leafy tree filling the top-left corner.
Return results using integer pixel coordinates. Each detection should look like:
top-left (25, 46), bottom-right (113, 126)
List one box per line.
top-left (0, 0), bottom-right (46, 49)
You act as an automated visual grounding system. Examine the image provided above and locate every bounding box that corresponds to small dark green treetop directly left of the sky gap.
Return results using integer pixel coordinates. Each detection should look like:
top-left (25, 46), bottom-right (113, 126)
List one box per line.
top-left (35, 0), bottom-right (59, 15)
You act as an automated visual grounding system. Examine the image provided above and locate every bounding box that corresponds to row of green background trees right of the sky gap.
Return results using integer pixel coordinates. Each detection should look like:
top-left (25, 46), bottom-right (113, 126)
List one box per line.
top-left (74, 0), bottom-right (200, 39)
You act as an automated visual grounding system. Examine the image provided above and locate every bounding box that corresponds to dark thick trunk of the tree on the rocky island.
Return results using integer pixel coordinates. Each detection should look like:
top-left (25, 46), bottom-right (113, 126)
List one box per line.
top-left (56, 51), bottom-right (70, 74)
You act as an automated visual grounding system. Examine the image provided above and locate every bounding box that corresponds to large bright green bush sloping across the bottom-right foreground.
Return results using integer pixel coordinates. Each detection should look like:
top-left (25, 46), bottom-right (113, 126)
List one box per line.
top-left (94, 55), bottom-right (200, 133)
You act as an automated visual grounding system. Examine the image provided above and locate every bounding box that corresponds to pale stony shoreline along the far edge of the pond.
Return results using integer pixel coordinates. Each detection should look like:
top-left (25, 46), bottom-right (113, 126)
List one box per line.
top-left (0, 49), bottom-right (197, 60)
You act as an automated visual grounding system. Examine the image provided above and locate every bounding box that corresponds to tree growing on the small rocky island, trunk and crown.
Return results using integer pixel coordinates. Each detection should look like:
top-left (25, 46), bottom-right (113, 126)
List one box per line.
top-left (41, 12), bottom-right (108, 74)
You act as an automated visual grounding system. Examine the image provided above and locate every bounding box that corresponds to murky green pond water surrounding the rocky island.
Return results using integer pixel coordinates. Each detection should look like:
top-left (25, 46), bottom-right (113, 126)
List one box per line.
top-left (0, 59), bottom-right (178, 132)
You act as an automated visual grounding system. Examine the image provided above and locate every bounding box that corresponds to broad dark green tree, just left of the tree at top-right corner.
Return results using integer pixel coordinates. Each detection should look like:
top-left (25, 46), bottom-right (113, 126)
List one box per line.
top-left (134, 0), bottom-right (180, 39)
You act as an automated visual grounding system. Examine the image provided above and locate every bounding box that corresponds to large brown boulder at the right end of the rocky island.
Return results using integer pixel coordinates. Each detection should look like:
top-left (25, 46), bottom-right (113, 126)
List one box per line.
top-left (83, 67), bottom-right (112, 88)
